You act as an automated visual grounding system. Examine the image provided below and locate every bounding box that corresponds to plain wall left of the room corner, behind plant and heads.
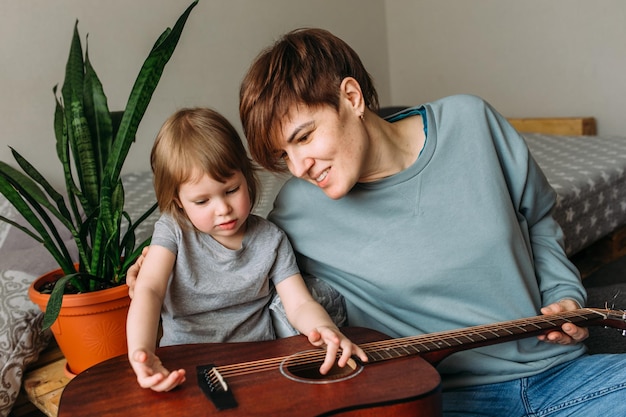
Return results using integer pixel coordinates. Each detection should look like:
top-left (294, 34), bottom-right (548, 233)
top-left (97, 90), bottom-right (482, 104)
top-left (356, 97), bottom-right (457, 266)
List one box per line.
top-left (0, 0), bottom-right (390, 185)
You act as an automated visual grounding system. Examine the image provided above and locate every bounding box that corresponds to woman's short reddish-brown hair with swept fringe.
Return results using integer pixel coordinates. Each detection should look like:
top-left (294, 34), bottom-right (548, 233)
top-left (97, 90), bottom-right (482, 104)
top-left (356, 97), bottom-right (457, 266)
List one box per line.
top-left (239, 28), bottom-right (378, 172)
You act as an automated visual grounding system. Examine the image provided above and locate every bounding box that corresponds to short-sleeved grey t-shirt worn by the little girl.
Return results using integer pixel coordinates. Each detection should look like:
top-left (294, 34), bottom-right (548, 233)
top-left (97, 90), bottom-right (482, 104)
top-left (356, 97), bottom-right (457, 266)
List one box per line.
top-left (151, 214), bottom-right (299, 346)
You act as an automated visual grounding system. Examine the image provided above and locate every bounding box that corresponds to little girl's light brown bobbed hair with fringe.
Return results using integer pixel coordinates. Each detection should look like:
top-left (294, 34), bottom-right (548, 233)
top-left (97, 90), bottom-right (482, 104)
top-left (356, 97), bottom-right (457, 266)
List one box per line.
top-left (150, 108), bottom-right (258, 225)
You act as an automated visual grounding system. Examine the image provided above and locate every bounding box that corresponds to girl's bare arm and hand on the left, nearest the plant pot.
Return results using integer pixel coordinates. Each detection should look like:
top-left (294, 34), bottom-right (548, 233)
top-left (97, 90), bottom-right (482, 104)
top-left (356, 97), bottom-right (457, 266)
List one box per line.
top-left (126, 245), bottom-right (185, 391)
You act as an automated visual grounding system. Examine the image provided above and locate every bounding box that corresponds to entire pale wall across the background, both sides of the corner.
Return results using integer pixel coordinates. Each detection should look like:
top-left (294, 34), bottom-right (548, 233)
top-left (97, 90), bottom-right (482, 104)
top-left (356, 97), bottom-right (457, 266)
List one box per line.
top-left (0, 0), bottom-right (626, 190)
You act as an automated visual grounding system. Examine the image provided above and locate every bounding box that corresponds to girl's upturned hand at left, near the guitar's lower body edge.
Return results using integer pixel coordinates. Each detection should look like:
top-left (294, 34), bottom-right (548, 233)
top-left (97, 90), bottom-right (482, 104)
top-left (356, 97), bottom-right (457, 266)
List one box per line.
top-left (129, 350), bottom-right (186, 392)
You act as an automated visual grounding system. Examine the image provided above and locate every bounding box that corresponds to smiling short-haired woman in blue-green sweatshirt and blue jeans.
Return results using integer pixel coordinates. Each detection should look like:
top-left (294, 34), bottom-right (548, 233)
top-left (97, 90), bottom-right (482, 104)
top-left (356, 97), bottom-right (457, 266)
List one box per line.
top-left (235, 29), bottom-right (626, 416)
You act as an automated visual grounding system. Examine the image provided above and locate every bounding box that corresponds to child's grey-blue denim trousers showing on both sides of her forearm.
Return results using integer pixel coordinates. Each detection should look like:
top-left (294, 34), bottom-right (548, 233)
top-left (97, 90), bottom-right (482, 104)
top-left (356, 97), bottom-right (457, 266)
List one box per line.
top-left (269, 276), bottom-right (348, 338)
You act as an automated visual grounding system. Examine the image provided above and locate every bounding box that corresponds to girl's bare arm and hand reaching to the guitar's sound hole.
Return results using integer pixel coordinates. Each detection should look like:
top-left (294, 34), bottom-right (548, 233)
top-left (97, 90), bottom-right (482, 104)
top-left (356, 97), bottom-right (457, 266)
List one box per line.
top-left (276, 274), bottom-right (367, 374)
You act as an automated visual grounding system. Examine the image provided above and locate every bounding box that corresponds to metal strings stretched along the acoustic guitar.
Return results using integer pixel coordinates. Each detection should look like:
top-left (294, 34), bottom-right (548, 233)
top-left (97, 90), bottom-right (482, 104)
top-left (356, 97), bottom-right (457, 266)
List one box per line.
top-left (211, 309), bottom-right (605, 377)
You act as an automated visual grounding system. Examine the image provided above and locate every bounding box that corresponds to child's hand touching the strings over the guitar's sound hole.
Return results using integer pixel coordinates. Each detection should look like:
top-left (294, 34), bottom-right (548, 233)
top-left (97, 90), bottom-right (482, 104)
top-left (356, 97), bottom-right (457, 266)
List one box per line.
top-left (308, 326), bottom-right (367, 375)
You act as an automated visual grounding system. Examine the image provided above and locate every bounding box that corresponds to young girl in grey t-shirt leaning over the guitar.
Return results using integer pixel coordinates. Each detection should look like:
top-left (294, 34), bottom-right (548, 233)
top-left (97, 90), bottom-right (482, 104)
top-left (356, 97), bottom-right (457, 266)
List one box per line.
top-left (127, 108), bottom-right (367, 391)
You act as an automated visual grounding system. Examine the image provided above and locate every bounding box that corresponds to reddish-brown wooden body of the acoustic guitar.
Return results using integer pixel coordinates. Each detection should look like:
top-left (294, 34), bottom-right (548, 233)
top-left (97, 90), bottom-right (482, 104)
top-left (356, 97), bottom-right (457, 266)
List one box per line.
top-left (59, 328), bottom-right (441, 417)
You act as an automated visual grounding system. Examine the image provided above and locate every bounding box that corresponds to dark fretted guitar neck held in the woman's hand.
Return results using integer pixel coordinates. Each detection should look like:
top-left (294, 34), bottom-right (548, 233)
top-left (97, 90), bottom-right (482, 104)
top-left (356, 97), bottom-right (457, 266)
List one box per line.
top-left (361, 308), bottom-right (626, 363)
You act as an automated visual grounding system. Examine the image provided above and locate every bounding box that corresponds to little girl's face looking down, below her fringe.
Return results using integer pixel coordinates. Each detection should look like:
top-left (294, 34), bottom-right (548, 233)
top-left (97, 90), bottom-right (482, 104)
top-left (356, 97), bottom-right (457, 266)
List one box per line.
top-left (177, 171), bottom-right (251, 249)
